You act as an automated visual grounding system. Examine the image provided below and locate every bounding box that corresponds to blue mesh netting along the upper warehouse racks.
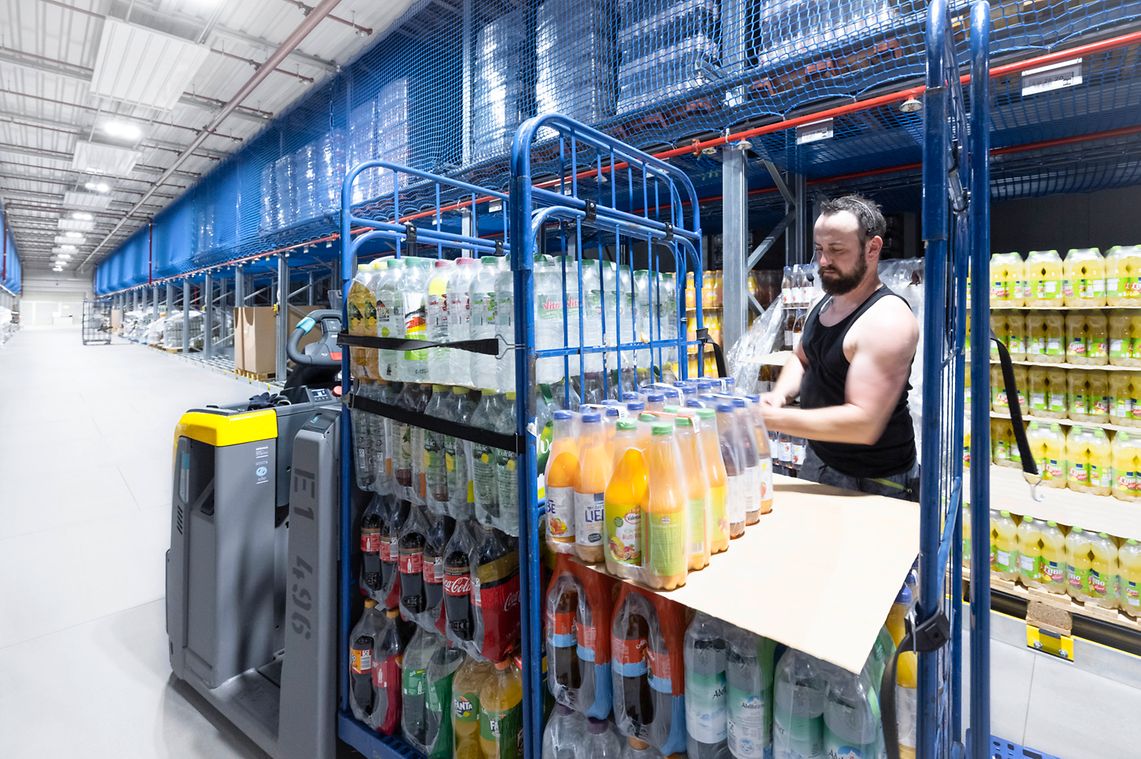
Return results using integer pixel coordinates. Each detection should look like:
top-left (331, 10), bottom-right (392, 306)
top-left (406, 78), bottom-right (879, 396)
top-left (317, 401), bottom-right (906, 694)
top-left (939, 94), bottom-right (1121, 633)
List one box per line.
top-left (99, 0), bottom-right (1141, 292)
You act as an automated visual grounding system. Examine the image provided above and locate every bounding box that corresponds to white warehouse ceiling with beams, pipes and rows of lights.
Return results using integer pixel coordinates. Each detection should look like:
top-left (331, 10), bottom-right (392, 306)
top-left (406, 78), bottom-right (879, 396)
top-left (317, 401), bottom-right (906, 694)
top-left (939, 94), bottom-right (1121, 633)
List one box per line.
top-left (0, 0), bottom-right (424, 274)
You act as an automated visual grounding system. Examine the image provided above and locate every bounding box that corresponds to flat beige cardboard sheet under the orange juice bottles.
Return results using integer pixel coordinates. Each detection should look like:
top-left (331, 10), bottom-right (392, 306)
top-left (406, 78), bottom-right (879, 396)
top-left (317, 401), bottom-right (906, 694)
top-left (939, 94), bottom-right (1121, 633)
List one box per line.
top-left (593, 475), bottom-right (920, 672)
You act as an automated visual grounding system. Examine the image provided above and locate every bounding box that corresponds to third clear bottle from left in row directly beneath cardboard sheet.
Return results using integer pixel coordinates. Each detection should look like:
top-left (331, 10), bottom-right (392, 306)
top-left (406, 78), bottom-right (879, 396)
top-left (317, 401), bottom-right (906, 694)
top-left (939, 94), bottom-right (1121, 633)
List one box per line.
top-left (772, 648), bottom-right (827, 759)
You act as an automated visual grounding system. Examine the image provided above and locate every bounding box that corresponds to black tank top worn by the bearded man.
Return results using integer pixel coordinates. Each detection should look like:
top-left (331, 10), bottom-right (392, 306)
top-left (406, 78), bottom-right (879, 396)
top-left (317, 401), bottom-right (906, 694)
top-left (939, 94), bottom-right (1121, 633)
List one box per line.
top-left (800, 286), bottom-right (915, 477)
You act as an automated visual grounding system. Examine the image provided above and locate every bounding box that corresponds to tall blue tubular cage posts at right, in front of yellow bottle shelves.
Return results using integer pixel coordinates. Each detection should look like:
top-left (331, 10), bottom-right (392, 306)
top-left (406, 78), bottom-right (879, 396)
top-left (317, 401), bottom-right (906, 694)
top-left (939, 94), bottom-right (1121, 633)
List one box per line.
top-left (916, 0), bottom-right (990, 759)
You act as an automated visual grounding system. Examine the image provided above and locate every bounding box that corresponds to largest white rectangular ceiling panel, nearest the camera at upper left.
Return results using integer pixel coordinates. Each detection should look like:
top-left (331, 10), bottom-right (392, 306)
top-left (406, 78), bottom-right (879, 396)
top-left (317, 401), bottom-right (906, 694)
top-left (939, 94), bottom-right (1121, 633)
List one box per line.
top-left (91, 18), bottom-right (210, 111)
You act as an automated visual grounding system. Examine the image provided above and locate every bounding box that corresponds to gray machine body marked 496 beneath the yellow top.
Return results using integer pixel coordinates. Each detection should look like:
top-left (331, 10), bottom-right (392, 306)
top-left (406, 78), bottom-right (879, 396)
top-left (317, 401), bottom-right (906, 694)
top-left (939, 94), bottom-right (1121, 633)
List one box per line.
top-left (167, 391), bottom-right (340, 759)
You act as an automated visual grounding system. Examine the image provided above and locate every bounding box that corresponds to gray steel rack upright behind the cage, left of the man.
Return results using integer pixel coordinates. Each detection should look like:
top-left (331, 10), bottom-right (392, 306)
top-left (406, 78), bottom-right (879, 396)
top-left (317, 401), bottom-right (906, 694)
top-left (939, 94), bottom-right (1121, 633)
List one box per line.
top-left (721, 143), bottom-right (750, 350)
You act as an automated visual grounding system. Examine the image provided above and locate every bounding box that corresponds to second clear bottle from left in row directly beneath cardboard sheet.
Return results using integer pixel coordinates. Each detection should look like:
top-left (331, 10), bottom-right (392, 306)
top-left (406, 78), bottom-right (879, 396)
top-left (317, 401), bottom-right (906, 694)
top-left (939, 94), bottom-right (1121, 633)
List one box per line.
top-left (726, 625), bottom-right (776, 759)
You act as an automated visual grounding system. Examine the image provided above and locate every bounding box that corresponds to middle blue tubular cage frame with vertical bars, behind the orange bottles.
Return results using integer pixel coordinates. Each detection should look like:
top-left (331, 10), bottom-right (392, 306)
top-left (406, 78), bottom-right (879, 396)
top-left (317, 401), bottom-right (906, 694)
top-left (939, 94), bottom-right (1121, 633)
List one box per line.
top-left (508, 113), bottom-right (704, 757)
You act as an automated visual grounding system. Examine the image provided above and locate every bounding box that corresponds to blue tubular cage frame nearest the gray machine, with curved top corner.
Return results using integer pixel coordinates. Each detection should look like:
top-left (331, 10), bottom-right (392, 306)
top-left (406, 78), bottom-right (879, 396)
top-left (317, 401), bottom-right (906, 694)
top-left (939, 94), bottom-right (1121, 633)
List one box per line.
top-left (337, 161), bottom-right (506, 758)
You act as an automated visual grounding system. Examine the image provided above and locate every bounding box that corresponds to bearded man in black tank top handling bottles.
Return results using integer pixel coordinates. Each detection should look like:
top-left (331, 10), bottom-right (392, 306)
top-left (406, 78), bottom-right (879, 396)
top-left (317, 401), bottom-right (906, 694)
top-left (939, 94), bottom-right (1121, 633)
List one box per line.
top-left (762, 195), bottom-right (919, 500)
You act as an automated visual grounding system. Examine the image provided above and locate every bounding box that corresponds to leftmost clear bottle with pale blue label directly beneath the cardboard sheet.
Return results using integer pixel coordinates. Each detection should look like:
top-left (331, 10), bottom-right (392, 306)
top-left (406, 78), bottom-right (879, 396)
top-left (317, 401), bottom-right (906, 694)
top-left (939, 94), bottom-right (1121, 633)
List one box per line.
top-left (685, 613), bottom-right (729, 759)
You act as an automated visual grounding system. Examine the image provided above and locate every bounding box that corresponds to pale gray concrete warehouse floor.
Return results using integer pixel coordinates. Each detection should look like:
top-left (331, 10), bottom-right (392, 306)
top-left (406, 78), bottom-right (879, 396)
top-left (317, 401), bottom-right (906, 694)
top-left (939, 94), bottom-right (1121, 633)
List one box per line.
top-left (0, 330), bottom-right (1141, 759)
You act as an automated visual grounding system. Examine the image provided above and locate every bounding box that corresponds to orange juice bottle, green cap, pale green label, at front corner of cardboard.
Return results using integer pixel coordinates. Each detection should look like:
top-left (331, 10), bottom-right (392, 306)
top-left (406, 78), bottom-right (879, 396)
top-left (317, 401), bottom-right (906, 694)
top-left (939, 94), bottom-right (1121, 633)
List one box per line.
top-left (642, 421), bottom-right (688, 590)
